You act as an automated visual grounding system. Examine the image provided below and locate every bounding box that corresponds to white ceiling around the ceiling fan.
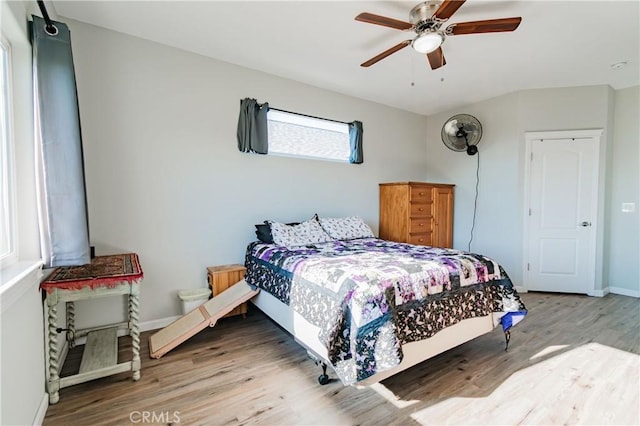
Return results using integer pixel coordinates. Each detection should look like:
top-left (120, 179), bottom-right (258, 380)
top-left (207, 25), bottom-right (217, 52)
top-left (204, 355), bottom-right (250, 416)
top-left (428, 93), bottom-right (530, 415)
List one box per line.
top-left (47, 0), bottom-right (640, 115)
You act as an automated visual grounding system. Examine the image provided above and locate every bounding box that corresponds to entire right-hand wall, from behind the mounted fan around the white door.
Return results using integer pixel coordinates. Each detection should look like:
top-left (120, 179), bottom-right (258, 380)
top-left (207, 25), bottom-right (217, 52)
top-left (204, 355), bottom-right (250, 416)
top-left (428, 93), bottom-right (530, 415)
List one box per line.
top-left (427, 86), bottom-right (640, 296)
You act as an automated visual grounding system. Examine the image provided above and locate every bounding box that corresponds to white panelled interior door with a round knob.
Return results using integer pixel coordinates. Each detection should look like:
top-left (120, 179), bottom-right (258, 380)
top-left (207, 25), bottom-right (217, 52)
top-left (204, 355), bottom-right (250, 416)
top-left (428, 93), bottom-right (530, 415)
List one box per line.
top-left (525, 131), bottom-right (599, 293)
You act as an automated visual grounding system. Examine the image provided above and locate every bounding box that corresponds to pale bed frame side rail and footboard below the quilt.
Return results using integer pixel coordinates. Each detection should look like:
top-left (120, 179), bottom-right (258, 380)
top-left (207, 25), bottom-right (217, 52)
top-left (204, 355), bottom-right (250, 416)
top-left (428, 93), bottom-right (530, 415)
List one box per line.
top-left (250, 282), bottom-right (495, 386)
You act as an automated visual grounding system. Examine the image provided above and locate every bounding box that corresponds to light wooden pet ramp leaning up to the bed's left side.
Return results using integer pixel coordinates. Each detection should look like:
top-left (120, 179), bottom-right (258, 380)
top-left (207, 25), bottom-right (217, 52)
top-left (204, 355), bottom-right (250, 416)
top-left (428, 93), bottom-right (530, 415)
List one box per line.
top-left (149, 280), bottom-right (260, 358)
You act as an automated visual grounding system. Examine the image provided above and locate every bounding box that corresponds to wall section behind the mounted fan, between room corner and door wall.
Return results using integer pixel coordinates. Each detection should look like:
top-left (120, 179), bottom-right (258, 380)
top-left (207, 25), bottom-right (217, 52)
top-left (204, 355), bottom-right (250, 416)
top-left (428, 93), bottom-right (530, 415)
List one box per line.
top-left (427, 94), bottom-right (523, 285)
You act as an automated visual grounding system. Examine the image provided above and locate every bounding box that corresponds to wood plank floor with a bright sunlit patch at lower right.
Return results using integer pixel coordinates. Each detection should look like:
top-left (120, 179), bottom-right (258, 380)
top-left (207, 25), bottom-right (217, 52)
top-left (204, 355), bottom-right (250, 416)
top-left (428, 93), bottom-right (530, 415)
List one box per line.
top-left (44, 293), bottom-right (640, 426)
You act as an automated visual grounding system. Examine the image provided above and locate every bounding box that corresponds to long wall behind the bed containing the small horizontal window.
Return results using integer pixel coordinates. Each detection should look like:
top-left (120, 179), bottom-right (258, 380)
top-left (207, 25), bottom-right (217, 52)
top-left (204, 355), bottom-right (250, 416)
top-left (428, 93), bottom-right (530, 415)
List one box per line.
top-left (67, 21), bottom-right (427, 323)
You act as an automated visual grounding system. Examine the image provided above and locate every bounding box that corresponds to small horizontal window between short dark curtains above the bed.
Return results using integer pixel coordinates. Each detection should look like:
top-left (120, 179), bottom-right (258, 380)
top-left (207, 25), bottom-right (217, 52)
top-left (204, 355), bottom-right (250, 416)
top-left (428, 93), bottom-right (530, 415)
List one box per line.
top-left (267, 108), bottom-right (351, 163)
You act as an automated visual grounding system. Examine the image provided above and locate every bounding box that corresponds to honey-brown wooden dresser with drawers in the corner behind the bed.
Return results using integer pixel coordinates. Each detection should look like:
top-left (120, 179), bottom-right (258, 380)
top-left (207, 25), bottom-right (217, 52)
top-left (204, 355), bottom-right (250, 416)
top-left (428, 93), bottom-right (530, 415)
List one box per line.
top-left (379, 182), bottom-right (455, 248)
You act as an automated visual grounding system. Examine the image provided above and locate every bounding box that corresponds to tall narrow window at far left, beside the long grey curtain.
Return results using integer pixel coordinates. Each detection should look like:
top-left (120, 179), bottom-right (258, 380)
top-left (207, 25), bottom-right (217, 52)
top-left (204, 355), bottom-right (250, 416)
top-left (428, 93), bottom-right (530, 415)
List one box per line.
top-left (0, 37), bottom-right (16, 265)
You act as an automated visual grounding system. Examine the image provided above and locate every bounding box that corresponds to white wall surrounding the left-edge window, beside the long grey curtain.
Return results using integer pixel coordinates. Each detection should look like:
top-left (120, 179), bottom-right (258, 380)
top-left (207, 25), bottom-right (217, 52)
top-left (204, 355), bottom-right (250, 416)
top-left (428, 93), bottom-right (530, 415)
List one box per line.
top-left (0, 1), bottom-right (46, 425)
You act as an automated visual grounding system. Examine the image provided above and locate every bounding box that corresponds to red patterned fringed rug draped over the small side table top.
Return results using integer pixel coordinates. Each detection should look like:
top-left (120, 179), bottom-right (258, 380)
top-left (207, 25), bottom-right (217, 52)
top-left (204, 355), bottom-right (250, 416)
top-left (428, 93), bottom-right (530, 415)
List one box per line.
top-left (40, 253), bottom-right (143, 293)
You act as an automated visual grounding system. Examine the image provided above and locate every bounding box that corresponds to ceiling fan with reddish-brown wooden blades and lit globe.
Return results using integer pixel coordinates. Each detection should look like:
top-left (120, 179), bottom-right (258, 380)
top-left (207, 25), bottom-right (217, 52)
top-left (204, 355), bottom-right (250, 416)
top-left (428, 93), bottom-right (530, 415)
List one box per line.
top-left (355, 0), bottom-right (522, 70)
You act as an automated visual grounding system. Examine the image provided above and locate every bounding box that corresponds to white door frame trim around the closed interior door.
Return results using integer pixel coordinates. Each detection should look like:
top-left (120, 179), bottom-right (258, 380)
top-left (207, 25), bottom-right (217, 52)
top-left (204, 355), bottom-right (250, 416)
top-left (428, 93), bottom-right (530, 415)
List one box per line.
top-left (522, 129), bottom-right (606, 297)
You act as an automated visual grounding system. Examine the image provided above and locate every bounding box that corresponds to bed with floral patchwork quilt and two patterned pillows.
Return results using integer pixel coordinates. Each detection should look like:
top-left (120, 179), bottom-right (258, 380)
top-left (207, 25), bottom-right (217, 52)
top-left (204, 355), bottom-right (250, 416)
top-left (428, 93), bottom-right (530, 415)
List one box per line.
top-left (245, 217), bottom-right (527, 385)
